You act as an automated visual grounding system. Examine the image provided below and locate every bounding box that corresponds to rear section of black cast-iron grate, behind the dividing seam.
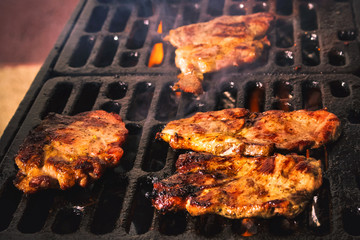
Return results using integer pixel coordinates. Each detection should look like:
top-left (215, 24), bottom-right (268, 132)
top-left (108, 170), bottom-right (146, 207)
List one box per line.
top-left (55, 0), bottom-right (360, 74)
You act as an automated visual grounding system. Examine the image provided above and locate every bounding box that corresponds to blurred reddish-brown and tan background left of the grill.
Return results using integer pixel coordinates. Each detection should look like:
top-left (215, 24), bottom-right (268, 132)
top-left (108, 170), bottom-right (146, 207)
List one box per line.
top-left (0, 0), bottom-right (79, 136)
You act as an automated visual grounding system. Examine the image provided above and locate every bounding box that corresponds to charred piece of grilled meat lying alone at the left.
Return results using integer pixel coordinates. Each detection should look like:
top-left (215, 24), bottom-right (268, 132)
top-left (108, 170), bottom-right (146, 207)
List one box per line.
top-left (14, 110), bottom-right (128, 193)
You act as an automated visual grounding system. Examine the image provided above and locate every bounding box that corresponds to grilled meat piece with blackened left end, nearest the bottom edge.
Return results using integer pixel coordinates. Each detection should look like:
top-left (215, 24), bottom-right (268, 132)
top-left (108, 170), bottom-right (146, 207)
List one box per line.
top-left (152, 153), bottom-right (322, 218)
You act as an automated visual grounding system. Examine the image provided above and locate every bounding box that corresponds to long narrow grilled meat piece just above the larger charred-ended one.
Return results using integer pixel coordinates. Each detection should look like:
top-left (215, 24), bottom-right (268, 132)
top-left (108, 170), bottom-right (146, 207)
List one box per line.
top-left (157, 108), bottom-right (340, 156)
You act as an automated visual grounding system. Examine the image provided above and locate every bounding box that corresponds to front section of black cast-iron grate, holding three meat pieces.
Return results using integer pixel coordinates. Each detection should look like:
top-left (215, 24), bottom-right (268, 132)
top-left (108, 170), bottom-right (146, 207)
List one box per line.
top-left (0, 74), bottom-right (360, 239)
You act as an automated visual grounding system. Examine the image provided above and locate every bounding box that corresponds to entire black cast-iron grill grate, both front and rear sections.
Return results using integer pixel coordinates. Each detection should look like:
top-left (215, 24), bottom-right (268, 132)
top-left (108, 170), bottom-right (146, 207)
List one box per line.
top-left (0, 0), bottom-right (360, 239)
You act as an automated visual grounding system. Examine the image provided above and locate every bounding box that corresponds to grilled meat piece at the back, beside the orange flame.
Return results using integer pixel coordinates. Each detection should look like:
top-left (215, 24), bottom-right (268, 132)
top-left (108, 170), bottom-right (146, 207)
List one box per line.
top-left (165, 13), bottom-right (274, 95)
